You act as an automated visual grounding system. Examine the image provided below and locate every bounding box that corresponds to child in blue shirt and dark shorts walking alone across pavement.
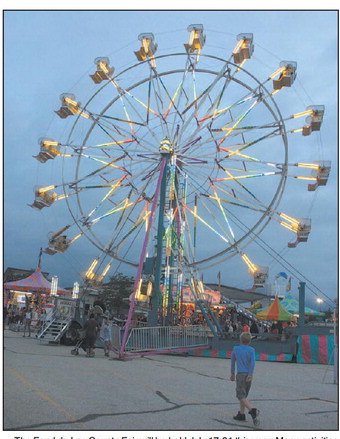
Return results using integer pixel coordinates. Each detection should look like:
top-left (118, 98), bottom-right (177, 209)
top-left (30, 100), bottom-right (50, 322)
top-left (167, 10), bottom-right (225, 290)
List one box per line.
top-left (230, 332), bottom-right (260, 425)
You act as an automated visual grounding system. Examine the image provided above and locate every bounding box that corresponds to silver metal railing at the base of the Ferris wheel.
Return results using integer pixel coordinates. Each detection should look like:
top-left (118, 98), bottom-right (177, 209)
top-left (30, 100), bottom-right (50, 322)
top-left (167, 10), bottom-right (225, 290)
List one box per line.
top-left (125, 325), bottom-right (212, 352)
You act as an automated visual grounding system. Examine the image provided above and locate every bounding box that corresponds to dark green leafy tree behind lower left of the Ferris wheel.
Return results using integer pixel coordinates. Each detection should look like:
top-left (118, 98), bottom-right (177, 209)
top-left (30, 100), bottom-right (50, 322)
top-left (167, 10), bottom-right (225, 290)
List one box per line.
top-left (98, 273), bottom-right (134, 316)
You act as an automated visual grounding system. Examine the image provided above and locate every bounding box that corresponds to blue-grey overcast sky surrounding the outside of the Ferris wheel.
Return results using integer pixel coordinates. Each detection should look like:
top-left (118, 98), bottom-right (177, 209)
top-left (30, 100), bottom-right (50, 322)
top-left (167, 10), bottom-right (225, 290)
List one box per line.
top-left (4, 11), bottom-right (338, 312)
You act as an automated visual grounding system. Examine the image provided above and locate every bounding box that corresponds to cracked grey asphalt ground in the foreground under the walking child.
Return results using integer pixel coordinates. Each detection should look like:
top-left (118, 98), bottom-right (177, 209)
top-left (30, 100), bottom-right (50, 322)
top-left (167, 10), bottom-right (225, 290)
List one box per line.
top-left (3, 330), bottom-right (338, 439)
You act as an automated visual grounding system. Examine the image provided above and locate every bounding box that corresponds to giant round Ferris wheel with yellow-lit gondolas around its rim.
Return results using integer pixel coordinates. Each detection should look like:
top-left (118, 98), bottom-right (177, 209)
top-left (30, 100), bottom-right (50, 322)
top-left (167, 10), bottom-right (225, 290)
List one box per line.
top-left (32, 24), bottom-right (330, 318)
